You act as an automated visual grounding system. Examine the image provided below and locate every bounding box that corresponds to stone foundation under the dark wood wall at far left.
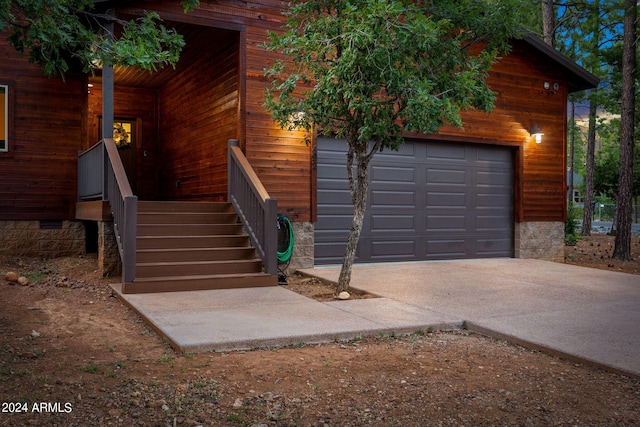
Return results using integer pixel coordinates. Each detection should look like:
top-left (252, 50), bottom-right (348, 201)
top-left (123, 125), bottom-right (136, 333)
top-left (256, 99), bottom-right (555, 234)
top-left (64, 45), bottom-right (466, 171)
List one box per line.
top-left (0, 221), bottom-right (86, 258)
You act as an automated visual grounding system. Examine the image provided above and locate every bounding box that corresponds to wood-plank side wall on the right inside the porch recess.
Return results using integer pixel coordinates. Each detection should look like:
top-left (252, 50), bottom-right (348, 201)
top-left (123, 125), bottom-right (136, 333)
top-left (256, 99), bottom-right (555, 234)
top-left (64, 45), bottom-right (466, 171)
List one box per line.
top-left (158, 35), bottom-right (238, 201)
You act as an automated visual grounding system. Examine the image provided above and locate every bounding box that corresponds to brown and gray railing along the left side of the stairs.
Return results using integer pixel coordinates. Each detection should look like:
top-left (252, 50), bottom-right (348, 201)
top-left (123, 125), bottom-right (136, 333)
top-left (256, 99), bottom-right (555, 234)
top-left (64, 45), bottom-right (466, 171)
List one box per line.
top-left (78, 138), bottom-right (138, 283)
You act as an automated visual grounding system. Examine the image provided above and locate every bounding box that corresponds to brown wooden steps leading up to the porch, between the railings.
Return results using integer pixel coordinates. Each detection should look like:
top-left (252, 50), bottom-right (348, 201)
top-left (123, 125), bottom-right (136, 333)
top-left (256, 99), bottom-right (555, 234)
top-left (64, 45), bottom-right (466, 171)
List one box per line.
top-left (122, 201), bottom-right (278, 294)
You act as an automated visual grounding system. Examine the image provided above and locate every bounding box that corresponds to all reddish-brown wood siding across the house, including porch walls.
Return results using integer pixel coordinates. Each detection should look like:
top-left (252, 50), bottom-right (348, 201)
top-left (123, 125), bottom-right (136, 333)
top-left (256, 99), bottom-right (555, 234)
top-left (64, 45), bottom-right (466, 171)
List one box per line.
top-left (0, 0), bottom-right (584, 227)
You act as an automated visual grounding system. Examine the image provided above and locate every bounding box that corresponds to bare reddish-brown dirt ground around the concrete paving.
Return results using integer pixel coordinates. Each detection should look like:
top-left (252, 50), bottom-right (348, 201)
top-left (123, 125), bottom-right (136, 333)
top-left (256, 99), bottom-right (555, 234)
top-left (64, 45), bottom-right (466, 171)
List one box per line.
top-left (0, 236), bottom-right (640, 426)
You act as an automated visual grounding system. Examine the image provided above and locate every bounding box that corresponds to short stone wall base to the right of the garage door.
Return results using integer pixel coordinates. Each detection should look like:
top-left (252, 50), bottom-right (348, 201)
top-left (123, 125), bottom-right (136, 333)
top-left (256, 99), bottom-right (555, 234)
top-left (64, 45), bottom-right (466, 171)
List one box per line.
top-left (514, 222), bottom-right (564, 262)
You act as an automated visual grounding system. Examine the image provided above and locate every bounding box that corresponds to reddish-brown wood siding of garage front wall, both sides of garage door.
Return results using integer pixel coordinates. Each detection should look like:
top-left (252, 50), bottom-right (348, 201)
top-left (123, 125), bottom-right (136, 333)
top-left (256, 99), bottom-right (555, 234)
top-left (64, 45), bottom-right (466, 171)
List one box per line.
top-left (125, 0), bottom-right (567, 221)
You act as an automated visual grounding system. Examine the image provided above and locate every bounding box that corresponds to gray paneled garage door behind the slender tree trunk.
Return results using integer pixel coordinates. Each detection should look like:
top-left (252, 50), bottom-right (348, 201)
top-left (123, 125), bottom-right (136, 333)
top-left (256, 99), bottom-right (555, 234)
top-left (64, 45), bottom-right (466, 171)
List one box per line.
top-left (315, 138), bottom-right (513, 264)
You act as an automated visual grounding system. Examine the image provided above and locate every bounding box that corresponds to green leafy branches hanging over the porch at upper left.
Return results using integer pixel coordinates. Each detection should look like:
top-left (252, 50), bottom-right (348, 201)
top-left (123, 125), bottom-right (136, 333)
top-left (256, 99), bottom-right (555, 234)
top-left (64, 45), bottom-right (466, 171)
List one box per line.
top-left (0, 0), bottom-right (199, 76)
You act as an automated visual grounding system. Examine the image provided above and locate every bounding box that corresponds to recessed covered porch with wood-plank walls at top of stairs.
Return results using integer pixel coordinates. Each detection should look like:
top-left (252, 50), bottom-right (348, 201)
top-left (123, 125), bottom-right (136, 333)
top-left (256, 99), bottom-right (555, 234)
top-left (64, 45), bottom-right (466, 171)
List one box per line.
top-left (85, 22), bottom-right (242, 201)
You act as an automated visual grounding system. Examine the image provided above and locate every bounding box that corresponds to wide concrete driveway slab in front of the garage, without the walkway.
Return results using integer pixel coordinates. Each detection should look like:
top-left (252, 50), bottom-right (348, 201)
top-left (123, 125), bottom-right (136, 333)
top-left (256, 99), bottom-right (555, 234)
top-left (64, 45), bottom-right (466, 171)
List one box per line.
top-left (306, 259), bottom-right (640, 375)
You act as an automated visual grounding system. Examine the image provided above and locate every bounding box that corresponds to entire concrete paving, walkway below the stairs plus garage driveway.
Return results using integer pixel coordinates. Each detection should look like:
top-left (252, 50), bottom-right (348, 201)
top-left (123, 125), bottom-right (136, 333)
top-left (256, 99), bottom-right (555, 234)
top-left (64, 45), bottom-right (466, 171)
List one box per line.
top-left (113, 259), bottom-right (640, 376)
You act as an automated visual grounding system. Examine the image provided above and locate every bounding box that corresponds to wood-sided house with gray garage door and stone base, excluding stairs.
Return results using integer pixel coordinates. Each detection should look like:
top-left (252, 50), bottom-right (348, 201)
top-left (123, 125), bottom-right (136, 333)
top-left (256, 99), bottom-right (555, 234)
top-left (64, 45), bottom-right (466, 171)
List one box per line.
top-left (0, 0), bottom-right (598, 292)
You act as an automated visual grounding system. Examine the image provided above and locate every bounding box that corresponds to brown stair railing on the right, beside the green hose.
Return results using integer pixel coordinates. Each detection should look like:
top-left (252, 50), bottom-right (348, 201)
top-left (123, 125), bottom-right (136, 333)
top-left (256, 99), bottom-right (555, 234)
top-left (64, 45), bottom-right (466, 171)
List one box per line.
top-left (228, 139), bottom-right (278, 275)
